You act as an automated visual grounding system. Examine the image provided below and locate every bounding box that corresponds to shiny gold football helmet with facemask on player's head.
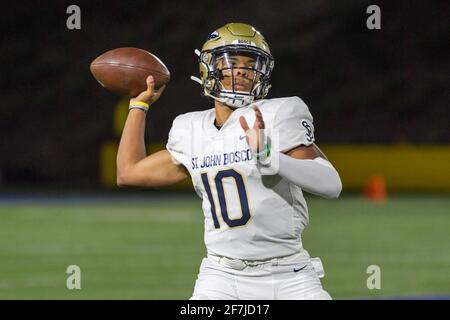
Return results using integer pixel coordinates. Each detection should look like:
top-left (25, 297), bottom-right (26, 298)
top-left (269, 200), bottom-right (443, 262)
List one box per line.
top-left (191, 23), bottom-right (274, 108)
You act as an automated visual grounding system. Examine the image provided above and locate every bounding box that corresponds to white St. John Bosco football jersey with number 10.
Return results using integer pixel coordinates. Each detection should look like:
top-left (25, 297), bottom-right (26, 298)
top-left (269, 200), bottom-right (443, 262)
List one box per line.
top-left (166, 97), bottom-right (314, 260)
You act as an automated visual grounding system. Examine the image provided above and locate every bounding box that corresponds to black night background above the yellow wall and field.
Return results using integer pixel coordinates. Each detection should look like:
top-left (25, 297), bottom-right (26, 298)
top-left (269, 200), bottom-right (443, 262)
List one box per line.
top-left (0, 0), bottom-right (450, 188)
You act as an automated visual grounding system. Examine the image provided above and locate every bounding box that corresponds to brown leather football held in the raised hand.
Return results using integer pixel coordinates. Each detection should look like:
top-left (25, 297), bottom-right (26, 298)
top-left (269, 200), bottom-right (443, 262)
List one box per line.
top-left (91, 47), bottom-right (170, 97)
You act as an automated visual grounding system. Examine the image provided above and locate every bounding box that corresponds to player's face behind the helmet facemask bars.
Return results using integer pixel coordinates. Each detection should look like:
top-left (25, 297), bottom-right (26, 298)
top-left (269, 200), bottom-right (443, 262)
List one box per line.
top-left (216, 54), bottom-right (259, 92)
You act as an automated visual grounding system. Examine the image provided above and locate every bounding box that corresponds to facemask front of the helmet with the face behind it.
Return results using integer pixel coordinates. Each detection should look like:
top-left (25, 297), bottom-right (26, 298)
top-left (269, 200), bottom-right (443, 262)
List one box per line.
top-left (200, 45), bottom-right (274, 108)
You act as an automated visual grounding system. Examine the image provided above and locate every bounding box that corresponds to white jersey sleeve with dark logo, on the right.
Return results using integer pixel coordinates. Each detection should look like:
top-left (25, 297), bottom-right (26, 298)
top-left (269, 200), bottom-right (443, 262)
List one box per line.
top-left (274, 97), bottom-right (315, 152)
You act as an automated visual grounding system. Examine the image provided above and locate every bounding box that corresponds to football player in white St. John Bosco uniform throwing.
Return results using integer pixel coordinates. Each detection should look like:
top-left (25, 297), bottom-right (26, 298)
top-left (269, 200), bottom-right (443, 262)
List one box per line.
top-left (117, 23), bottom-right (342, 299)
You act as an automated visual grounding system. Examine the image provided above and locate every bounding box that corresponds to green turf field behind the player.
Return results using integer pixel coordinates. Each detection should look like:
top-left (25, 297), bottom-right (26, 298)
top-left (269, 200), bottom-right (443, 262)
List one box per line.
top-left (0, 195), bottom-right (450, 299)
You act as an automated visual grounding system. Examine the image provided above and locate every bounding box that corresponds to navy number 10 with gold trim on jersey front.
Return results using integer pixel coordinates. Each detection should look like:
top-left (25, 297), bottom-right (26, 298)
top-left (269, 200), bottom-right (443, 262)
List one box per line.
top-left (201, 169), bottom-right (250, 229)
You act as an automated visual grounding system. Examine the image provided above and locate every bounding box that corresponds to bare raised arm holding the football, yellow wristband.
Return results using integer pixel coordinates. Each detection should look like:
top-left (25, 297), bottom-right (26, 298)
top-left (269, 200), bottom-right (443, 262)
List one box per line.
top-left (117, 77), bottom-right (189, 187)
